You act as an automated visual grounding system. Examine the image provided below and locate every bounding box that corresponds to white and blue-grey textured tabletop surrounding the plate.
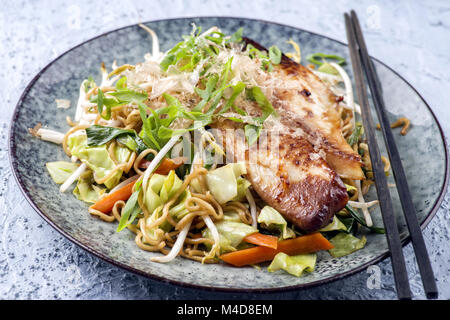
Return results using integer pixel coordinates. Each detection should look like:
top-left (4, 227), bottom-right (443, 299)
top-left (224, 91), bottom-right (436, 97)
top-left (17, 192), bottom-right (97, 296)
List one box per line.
top-left (0, 0), bottom-right (450, 299)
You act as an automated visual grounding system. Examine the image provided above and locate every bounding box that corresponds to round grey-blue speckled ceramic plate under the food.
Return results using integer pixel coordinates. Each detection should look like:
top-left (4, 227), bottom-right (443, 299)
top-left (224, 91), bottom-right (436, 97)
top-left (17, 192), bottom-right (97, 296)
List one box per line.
top-left (9, 17), bottom-right (448, 292)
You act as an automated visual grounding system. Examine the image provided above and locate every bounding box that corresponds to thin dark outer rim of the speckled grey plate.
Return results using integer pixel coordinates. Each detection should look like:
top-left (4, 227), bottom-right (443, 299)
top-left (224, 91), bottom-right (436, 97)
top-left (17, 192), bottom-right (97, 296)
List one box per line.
top-left (8, 15), bottom-right (450, 294)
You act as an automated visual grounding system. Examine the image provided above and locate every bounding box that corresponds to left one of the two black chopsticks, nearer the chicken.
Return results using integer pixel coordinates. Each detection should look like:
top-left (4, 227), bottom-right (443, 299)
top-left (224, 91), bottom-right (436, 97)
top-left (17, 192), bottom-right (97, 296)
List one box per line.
top-left (344, 13), bottom-right (411, 300)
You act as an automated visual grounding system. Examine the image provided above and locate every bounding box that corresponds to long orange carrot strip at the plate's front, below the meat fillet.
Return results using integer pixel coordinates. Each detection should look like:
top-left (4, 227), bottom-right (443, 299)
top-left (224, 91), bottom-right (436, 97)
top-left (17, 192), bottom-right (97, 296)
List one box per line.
top-left (220, 233), bottom-right (334, 267)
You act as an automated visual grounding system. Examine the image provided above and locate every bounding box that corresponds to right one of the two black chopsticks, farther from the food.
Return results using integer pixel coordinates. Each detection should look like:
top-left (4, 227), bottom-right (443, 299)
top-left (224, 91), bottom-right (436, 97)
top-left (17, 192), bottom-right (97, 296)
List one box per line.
top-left (351, 10), bottom-right (438, 299)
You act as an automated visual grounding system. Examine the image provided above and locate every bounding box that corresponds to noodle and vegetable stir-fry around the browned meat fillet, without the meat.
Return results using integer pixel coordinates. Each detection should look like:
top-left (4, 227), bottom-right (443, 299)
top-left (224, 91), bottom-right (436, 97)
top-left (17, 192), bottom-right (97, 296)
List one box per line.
top-left (30, 25), bottom-right (407, 276)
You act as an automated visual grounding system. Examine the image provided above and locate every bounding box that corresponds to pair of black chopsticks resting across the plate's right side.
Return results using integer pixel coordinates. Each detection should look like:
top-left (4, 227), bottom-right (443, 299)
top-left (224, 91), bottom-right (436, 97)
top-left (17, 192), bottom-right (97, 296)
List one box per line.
top-left (344, 10), bottom-right (438, 300)
